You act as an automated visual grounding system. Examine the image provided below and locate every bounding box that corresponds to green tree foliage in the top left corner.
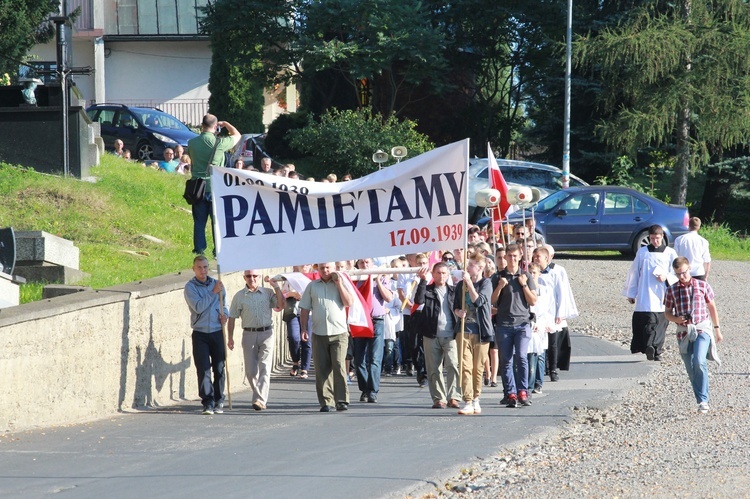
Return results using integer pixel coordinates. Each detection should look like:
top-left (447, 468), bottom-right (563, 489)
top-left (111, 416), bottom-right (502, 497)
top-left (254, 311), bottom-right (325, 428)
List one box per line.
top-left (0, 0), bottom-right (60, 76)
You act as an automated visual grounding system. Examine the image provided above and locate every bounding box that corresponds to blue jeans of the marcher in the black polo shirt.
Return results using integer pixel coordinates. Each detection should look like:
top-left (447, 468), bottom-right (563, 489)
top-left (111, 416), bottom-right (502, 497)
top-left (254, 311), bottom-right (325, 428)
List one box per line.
top-left (495, 323), bottom-right (531, 394)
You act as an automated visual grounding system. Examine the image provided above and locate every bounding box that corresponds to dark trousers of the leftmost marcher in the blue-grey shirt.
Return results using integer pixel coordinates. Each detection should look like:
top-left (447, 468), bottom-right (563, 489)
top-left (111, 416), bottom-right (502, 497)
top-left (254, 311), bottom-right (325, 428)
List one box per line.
top-left (193, 331), bottom-right (227, 407)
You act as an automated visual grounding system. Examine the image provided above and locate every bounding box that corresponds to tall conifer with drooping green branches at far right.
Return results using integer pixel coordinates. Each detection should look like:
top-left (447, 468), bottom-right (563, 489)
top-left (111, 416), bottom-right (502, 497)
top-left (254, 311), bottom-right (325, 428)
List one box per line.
top-left (576, 0), bottom-right (750, 204)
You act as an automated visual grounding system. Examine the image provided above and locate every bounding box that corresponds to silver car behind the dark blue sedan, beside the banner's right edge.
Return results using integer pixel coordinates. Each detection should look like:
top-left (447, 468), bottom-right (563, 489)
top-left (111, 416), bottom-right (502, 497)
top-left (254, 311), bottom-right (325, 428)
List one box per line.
top-left (469, 158), bottom-right (589, 222)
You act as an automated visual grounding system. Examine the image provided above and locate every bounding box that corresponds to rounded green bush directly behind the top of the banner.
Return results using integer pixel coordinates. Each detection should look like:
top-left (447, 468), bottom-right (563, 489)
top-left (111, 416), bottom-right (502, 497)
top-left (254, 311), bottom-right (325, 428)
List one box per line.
top-left (288, 109), bottom-right (434, 177)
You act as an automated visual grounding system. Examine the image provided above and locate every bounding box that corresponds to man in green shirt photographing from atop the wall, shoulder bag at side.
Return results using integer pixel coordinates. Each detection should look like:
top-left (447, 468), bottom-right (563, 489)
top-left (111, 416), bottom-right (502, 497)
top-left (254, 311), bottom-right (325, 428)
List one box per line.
top-left (188, 114), bottom-right (241, 256)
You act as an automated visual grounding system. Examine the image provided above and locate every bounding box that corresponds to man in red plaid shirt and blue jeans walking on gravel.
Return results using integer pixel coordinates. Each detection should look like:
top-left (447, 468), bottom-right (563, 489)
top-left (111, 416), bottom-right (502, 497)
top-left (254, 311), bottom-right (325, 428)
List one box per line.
top-left (664, 256), bottom-right (722, 413)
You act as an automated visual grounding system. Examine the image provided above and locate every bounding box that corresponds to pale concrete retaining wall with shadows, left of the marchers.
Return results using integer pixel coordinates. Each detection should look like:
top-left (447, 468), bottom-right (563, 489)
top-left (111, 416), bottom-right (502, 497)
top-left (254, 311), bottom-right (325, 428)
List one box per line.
top-left (0, 269), bottom-right (288, 432)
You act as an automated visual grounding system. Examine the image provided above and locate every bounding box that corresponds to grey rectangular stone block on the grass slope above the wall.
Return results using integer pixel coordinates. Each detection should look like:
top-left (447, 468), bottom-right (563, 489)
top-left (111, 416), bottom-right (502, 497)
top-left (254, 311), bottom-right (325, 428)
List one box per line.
top-left (16, 230), bottom-right (80, 275)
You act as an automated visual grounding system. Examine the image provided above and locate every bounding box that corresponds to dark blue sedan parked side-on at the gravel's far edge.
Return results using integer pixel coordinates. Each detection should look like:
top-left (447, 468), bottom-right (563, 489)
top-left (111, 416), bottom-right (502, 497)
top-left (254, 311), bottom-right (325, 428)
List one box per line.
top-left (494, 185), bottom-right (690, 253)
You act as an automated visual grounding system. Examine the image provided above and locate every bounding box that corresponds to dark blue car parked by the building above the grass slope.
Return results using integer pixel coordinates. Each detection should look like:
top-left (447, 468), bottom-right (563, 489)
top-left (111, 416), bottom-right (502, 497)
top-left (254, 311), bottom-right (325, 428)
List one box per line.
top-left (86, 104), bottom-right (198, 161)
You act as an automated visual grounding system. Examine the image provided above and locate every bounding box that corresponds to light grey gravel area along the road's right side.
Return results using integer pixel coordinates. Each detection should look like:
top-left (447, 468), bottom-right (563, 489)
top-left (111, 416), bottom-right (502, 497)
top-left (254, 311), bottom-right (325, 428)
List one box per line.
top-left (439, 254), bottom-right (750, 498)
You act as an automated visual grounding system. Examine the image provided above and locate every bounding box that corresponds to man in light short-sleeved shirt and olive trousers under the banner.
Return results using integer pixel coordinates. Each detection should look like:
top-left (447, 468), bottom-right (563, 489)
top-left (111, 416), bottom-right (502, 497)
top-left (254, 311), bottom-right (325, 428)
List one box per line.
top-left (299, 262), bottom-right (355, 412)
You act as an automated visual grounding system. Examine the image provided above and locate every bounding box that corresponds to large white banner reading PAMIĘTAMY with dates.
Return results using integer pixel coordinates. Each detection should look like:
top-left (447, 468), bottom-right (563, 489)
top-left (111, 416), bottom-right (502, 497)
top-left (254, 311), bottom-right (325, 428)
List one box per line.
top-left (211, 139), bottom-right (469, 272)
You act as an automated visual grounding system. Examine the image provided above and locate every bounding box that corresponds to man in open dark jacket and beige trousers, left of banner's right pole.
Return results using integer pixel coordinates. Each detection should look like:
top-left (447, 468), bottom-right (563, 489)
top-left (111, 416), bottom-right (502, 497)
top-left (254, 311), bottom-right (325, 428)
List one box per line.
top-left (414, 262), bottom-right (460, 409)
